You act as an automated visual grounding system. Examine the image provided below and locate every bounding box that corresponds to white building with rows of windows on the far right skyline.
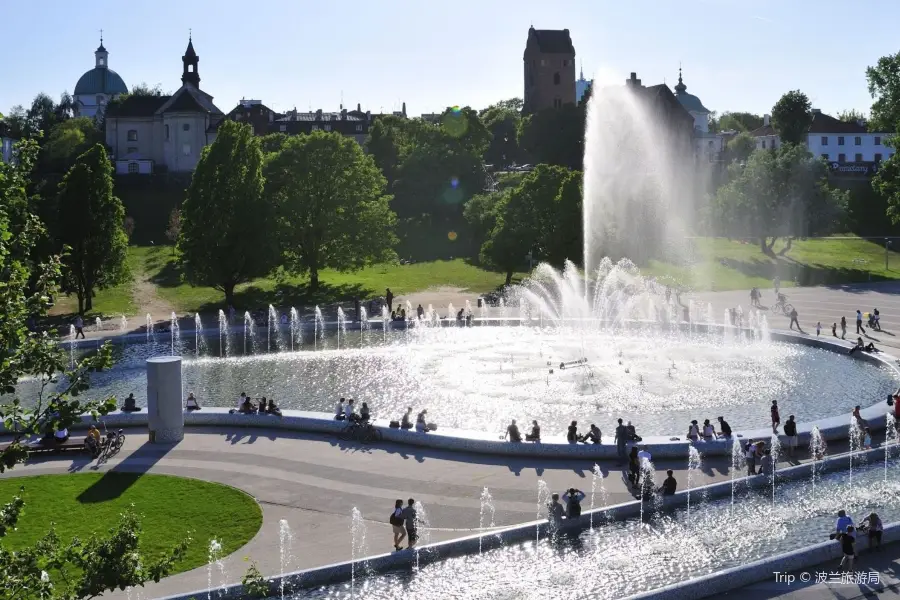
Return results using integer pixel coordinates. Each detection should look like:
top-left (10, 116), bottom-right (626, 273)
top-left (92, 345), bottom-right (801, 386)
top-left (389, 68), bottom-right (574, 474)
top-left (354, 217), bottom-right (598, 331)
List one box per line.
top-left (750, 108), bottom-right (894, 175)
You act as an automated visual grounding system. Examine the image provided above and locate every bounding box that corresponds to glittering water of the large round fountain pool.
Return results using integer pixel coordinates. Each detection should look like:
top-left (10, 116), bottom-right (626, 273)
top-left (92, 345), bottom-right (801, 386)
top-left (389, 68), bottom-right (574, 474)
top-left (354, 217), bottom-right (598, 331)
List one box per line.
top-left (29, 325), bottom-right (898, 436)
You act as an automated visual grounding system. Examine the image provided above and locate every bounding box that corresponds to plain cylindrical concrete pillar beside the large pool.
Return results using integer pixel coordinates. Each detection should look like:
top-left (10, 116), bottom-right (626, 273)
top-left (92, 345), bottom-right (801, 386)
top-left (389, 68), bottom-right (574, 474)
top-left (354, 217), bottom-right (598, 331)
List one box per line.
top-left (147, 356), bottom-right (184, 444)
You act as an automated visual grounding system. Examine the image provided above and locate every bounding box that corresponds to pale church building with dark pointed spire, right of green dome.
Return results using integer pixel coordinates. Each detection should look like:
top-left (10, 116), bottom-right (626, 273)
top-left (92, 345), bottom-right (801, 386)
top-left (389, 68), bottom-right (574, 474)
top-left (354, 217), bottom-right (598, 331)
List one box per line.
top-left (106, 40), bottom-right (223, 174)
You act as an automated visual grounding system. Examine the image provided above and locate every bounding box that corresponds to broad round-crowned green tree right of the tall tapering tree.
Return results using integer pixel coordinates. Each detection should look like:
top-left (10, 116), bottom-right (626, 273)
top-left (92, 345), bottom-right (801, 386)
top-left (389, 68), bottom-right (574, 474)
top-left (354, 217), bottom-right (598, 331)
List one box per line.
top-left (265, 132), bottom-right (396, 291)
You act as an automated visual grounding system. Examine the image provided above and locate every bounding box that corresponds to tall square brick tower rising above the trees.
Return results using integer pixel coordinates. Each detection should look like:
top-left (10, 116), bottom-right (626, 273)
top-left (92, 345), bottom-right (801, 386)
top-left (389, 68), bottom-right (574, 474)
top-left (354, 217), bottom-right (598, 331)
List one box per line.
top-left (522, 27), bottom-right (576, 114)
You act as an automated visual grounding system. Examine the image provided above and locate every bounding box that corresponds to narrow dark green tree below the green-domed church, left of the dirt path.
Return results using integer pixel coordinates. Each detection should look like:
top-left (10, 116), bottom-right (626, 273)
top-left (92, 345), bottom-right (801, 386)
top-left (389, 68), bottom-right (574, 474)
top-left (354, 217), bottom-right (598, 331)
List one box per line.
top-left (56, 144), bottom-right (128, 314)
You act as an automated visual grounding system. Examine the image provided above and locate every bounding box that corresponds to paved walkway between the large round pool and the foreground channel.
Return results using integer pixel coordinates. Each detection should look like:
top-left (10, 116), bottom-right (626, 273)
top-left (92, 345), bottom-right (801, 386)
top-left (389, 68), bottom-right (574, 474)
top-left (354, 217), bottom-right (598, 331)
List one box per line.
top-left (0, 428), bottom-right (838, 600)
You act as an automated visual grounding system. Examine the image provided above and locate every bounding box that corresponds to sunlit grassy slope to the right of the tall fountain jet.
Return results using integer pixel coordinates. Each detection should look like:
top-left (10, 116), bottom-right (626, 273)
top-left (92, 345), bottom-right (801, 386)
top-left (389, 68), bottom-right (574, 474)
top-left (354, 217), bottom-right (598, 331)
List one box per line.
top-left (642, 236), bottom-right (900, 290)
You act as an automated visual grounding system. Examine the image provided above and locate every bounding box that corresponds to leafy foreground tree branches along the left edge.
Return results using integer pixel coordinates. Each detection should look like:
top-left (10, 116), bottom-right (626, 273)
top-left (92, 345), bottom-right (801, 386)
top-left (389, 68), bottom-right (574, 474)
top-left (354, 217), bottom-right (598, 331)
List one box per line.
top-left (0, 142), bottom-right (188, 600)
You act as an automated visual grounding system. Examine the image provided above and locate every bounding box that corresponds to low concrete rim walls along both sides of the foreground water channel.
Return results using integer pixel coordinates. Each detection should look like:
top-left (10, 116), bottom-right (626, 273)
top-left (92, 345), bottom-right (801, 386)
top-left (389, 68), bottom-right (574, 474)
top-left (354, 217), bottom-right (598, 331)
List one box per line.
top-left (153, 448), bottom-right (900, 600)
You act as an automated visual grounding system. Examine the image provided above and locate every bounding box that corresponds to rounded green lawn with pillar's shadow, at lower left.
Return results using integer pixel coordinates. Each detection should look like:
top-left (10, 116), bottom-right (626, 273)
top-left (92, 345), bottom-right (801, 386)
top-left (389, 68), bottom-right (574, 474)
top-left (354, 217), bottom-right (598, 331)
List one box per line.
top-left (0, 472), bottom-right (262, 573)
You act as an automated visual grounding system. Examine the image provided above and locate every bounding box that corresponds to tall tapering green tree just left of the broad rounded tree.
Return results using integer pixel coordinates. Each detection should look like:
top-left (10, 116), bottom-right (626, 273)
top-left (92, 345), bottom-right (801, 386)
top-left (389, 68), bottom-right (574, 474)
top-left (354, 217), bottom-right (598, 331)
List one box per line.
top-left (178, 120), bottom-right (277, 306)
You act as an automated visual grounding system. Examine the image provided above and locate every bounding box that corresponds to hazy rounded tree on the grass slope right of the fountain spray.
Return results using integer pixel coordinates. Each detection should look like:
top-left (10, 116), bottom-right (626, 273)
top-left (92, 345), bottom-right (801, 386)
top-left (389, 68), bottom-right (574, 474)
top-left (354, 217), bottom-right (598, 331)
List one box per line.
top-left (713, 144), bottom-right (847, 256)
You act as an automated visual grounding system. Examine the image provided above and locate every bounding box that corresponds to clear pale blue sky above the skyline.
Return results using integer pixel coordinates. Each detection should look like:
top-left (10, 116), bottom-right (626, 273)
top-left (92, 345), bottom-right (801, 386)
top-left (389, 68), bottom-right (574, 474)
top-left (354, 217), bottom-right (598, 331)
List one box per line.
top-left (0, 0), bottom-right (900, 114)
